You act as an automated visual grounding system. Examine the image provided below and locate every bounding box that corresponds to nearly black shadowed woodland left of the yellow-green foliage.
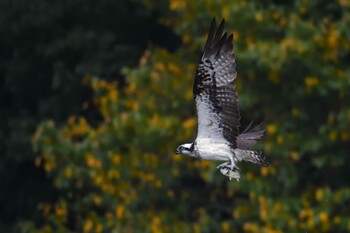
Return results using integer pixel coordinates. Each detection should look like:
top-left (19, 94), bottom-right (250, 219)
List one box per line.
top-left (0, 0), bottom-right (179, 231)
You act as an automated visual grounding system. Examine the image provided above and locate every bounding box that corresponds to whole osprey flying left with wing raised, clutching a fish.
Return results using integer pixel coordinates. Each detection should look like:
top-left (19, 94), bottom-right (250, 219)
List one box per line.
top-left (176, 18), bottom-right (268, 181)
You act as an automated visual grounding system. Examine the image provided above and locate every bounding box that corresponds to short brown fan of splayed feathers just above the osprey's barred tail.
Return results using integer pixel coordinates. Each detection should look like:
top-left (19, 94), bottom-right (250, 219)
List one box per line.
top-left (237, 121), bottom-right (265, 150)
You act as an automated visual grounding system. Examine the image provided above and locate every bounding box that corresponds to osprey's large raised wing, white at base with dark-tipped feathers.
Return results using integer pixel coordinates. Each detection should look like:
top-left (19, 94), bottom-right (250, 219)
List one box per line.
top-left (193, 19), bottom-right (240, 148)
